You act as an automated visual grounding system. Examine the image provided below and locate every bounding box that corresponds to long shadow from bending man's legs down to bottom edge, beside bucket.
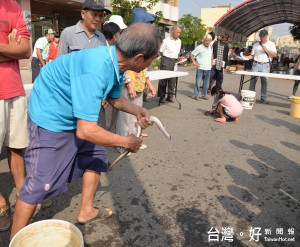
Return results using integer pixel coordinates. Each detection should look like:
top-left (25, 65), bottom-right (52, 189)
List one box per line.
top-left (83, 154), bottom-right (172, 247)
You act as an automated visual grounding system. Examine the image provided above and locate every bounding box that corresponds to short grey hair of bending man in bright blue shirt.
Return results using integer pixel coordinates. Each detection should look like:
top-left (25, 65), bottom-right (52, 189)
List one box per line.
top-left (116, 22), bottom-right (162, 59)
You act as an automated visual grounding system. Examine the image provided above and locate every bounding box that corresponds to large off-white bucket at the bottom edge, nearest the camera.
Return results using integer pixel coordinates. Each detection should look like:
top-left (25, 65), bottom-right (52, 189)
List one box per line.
top-left (9, 220), bottom-right (84, 247)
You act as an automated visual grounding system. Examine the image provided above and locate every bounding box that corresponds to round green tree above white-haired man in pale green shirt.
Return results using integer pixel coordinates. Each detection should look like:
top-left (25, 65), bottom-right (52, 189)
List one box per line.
top-left (178, 14), bottom-right (206, 45)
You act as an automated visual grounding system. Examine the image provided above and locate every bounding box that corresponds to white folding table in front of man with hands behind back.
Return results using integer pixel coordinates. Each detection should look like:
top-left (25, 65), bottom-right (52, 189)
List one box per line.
top-left (148, 70), bottom-right (189, 110)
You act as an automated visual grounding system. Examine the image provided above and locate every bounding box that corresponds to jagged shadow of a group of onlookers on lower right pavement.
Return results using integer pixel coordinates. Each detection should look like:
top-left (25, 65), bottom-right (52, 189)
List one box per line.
top-left (218, 140), bottom-right (300, 246)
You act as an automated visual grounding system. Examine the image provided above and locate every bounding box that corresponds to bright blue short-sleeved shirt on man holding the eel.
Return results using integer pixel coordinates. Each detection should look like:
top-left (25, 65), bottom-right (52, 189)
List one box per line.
top-left (28, 46), bottom-right (123, 132)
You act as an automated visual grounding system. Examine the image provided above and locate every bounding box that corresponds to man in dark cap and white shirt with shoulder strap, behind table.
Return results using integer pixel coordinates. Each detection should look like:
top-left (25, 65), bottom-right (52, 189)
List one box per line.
top-left (245, 30), bottom-right (277, 104)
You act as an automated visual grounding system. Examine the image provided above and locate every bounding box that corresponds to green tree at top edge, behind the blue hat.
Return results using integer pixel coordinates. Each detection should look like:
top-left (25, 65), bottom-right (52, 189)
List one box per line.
top-left (111, 0), bottom-right (163, 25)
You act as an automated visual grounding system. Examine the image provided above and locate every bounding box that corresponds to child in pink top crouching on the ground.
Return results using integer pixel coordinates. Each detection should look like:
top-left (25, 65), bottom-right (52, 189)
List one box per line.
top-left (211, 86), bottom-right (243, 123)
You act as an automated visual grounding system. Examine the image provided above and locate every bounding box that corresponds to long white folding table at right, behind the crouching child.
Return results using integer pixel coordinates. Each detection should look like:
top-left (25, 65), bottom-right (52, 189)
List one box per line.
top-left (233, 70), bottom-right (300, 97)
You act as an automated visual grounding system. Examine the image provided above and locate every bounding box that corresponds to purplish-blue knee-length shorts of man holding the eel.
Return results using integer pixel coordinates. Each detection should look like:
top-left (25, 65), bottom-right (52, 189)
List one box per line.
top-left (19, 118), bottom-right (108, 204)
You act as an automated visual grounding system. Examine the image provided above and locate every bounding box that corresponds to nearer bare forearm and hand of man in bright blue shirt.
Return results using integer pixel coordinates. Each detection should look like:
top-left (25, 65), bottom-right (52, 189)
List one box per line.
top-left (76, 119), bottom-right (142, 152)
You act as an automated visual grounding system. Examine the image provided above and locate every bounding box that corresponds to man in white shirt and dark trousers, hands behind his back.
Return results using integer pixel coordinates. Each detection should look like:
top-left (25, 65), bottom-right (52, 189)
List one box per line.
top-left (157, 25), bottom-right (182, 103)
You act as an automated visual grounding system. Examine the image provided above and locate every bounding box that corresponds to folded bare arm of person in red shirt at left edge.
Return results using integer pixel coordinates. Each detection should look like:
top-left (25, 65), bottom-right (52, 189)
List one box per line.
top-left (0, 29), bottom-right (31, 62)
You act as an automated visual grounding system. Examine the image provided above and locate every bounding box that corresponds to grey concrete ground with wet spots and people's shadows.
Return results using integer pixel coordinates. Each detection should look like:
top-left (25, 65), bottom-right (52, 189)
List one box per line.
top-left (0, 67), bottom-right (300, 247)
